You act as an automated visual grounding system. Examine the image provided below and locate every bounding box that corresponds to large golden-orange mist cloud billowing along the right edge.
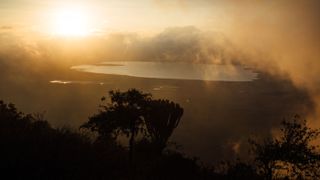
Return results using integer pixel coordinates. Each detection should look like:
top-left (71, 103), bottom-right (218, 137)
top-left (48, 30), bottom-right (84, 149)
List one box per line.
top-left (218, 0), bottom-right (320, 126)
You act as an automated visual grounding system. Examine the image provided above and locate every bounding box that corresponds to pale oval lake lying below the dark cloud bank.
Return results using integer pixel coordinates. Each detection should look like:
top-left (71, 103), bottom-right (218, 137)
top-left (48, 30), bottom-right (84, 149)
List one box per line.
top-left (71, 61), bottom-right (258, 81)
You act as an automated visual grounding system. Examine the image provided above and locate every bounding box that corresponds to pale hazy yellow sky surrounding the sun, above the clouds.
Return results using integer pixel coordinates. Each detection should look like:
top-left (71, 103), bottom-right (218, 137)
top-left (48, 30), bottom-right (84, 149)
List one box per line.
top-left (0, 0), bottom-right (227, 33)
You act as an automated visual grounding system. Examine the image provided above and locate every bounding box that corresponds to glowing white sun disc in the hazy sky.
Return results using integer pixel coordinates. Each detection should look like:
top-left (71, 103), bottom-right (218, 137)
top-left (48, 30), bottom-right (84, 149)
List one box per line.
top-left (53, 8), bottom-right (90, 36)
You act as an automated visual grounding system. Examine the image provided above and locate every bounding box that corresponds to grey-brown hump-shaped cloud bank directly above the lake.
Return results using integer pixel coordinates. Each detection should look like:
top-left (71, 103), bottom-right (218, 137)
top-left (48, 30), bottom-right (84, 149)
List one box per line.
top-left (85, 26), bottom-right (241, 64)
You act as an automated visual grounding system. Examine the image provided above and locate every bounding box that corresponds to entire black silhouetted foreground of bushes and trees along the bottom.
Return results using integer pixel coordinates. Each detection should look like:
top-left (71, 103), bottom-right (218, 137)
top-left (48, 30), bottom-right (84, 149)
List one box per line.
top-left (0, 89), bottom-right (320, 179)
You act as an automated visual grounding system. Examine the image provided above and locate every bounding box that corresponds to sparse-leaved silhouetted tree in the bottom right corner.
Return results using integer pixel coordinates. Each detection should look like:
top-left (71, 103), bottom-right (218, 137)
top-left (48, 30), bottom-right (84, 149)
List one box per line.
top-left (249, 116), bottom-right (320, 179)
